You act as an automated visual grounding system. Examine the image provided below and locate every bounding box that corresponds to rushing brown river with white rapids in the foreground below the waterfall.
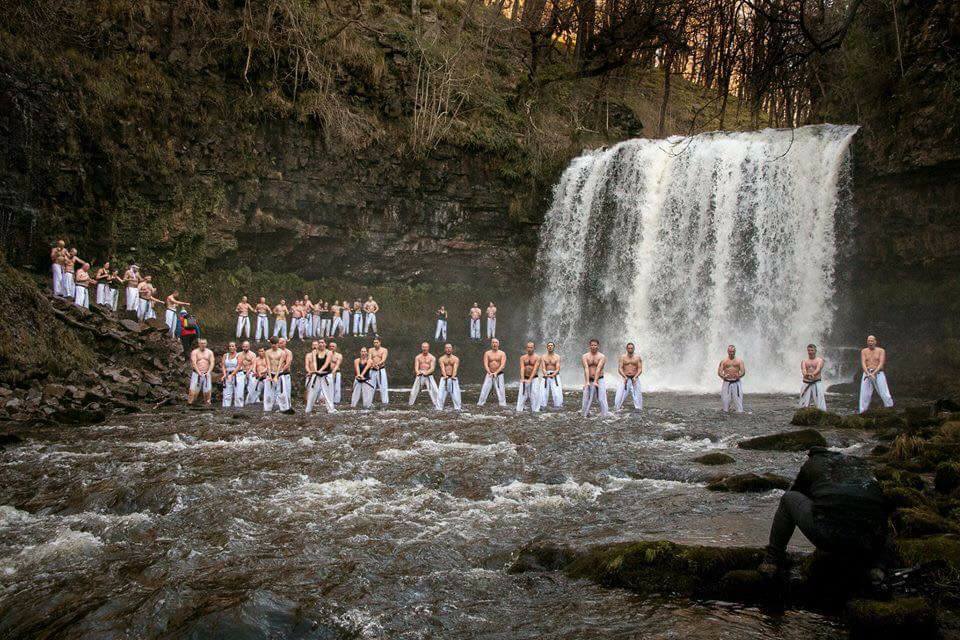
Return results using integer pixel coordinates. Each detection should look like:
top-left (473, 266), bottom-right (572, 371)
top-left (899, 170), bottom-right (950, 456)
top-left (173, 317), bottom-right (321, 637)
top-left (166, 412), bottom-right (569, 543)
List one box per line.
top-left (0, 389), bottom-right (869, 640)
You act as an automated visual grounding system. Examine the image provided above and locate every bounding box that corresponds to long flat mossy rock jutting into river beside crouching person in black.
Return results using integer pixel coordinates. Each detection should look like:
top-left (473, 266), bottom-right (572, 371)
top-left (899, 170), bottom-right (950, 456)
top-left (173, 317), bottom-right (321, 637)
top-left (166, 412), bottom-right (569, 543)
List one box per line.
top-left (565, 541), bottom-right (763, 598)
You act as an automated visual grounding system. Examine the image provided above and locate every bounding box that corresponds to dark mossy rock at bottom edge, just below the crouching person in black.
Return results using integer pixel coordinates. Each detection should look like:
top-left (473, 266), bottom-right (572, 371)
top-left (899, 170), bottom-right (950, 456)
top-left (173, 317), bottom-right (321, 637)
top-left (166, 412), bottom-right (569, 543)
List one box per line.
top-left (847, 597), bottom-right (937, 640)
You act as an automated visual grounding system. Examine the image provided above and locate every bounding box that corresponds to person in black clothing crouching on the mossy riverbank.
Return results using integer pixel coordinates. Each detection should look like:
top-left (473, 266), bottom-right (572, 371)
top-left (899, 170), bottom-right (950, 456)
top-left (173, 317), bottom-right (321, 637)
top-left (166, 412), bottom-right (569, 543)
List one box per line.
top-left (759, 447), bottom-right (888, 576)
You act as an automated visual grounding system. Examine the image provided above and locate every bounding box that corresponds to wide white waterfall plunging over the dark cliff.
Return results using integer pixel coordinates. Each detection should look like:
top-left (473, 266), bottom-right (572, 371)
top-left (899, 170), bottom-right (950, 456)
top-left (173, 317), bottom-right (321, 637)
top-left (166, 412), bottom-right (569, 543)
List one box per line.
top-left (537, 125), bottom-right (857, 392)
